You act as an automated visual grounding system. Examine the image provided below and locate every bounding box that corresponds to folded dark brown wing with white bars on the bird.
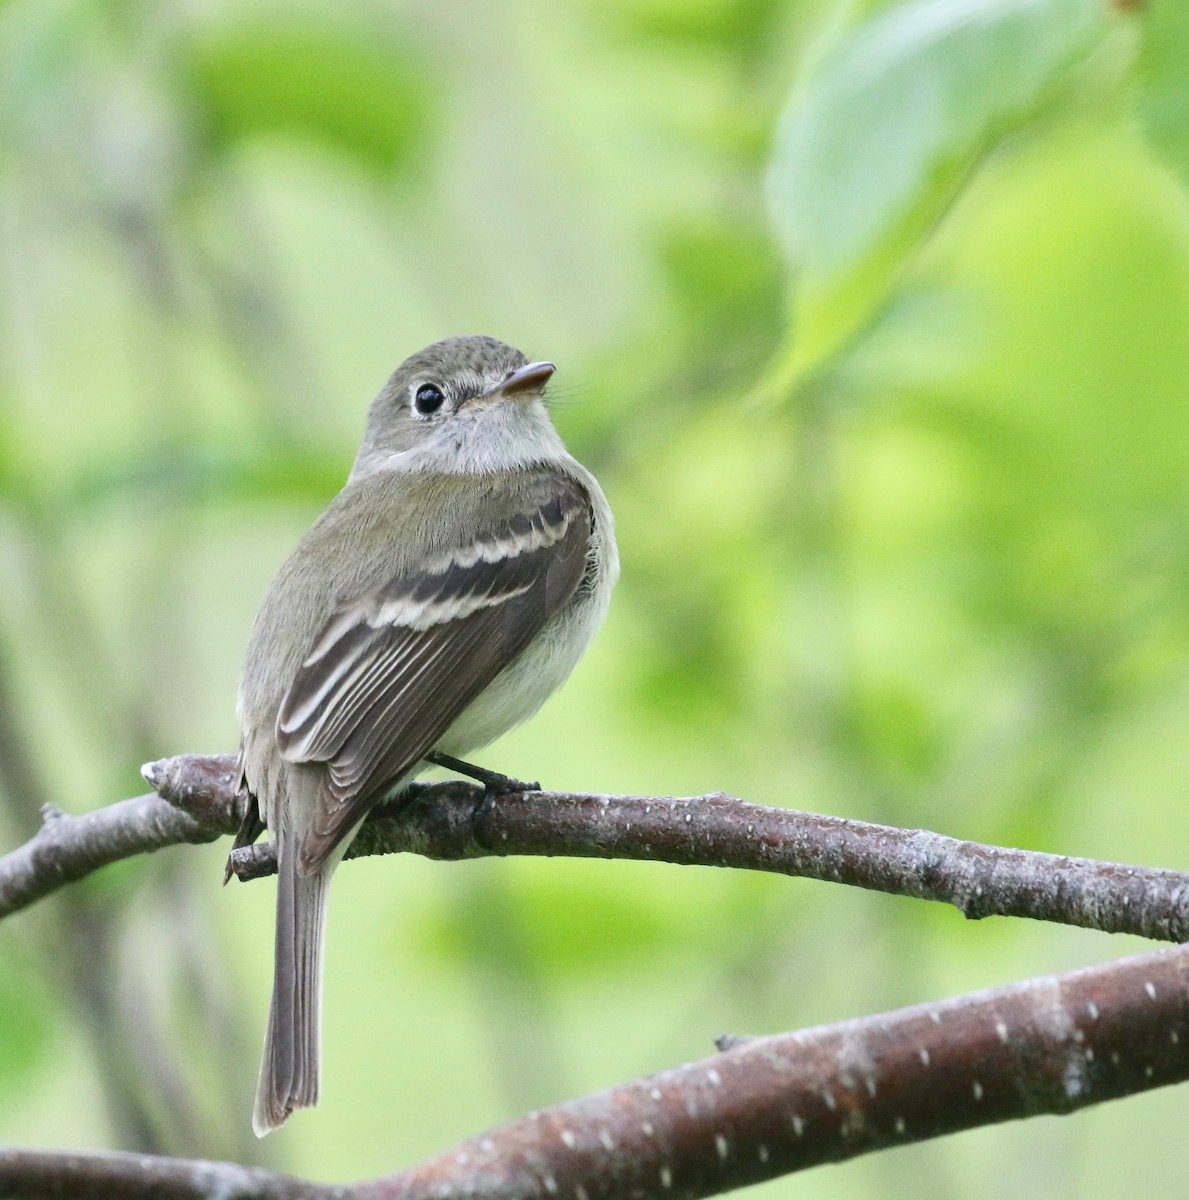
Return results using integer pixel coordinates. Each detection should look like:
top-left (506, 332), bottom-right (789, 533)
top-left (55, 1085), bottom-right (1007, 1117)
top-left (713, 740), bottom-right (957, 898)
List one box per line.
top-left (277, 475), bottom-right (592, 872)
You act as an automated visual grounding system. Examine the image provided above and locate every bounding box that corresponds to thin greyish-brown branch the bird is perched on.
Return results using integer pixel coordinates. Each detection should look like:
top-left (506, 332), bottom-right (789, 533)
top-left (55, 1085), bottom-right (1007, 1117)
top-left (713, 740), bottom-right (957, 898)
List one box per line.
top-left (0, 755), bottom-right (1189, 942)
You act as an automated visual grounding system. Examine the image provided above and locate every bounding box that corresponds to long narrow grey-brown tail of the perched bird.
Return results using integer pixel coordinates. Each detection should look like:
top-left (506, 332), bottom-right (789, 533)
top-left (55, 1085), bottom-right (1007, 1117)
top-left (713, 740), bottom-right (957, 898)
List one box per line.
top-left (252, 824), bottom-right (336, 1138)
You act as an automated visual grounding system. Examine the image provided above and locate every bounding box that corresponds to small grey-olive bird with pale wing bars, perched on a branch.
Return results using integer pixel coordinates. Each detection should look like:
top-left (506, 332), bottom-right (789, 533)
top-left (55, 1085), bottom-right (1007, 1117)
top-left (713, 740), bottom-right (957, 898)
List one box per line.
top-left (236, 337), bottom-right (619, 1136)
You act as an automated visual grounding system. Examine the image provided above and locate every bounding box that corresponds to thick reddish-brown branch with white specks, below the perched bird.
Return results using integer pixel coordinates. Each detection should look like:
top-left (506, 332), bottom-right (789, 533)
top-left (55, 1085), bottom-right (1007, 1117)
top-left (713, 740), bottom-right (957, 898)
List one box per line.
top-left (0, 947), bottom-right (1189, 1200)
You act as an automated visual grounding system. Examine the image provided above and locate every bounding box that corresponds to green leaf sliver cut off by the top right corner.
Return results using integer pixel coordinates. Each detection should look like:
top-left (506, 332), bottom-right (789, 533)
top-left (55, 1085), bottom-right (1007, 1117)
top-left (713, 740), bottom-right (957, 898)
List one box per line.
top-left (1139, 0), bottom-right (1189, 184)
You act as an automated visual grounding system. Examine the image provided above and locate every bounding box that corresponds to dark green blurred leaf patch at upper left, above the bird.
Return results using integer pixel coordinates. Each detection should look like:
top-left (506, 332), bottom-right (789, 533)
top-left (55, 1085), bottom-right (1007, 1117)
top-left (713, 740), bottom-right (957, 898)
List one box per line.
top-left (184, 13), bottom-right (434, 173)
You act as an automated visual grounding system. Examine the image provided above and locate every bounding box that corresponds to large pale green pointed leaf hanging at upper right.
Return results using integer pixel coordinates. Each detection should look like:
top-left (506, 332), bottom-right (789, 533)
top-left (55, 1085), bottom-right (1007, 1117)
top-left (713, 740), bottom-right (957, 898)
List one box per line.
top-left (768, 0), bottom-right (1109, 371)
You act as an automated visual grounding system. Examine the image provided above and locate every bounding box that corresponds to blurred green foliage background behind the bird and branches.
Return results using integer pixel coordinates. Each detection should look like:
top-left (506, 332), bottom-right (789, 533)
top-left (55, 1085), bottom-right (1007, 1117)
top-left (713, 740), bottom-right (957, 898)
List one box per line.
top-left (0, 0), bottom-right (1189, 1200)
